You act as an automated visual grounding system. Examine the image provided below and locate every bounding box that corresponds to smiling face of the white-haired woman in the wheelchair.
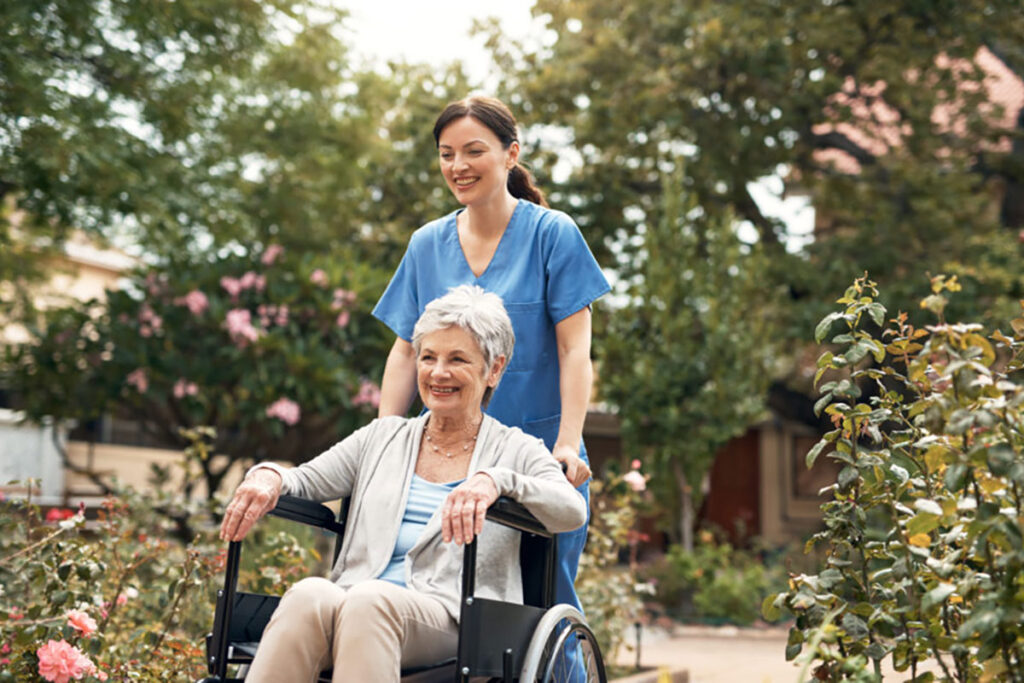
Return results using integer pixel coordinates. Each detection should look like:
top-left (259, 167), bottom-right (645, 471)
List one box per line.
top-left (416, 326), bottom-right (504, 419)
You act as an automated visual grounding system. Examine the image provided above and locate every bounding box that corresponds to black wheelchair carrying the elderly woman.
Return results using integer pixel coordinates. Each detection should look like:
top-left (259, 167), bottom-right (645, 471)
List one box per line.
top-left (199, 496), bottom-right (607, 683)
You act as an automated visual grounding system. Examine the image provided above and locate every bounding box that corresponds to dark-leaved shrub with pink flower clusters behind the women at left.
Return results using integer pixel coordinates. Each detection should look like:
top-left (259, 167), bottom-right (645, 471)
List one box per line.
top-left (3, 245), bottom-right (389, 494)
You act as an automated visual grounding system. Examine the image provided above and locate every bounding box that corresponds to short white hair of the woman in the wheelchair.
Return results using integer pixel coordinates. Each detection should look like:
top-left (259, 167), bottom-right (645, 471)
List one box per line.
top-left (413, 285), bottom-right (515, 407)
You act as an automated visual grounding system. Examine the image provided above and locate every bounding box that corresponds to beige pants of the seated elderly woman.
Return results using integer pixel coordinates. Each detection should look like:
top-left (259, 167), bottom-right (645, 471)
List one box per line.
top-left (246, 579), bottom-right (459, 683)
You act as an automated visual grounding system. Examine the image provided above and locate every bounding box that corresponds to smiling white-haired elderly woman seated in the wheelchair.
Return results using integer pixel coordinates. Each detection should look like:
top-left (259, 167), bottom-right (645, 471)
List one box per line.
top-left (220, 285), bottom-right (587, 683)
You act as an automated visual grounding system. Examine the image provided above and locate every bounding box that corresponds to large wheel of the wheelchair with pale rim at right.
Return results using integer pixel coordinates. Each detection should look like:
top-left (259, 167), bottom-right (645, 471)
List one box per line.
top-left (519, 605), bottom-right (608, 683)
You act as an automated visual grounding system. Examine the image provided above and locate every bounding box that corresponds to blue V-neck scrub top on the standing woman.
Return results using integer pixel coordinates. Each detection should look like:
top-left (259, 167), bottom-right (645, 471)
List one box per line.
top-left (374, 200), bottom-right (610, 449)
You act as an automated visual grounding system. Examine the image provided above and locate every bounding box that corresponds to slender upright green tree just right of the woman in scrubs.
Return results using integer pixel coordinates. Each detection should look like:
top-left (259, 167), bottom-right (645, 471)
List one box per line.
top-left (598, 173), bottom-right (771, 550)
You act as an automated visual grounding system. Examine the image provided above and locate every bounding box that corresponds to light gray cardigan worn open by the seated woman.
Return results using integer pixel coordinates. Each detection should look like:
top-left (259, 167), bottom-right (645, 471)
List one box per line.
top-left (275, 415), bottom-right (587, 622)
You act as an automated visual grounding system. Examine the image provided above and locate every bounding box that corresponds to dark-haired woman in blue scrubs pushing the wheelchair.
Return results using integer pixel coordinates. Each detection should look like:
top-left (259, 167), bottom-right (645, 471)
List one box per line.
top-left (374, 96), bottom-right (609, 608)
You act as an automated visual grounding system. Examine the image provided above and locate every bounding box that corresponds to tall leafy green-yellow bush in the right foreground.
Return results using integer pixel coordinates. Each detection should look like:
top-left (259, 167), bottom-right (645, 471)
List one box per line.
top-left (764, 276), bottom-right (1024, 681)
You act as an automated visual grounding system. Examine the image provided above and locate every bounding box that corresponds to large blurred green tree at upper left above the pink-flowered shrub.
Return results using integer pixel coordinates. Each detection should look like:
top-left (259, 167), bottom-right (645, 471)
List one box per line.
top-left (0, 0), bottom-right (468, 296)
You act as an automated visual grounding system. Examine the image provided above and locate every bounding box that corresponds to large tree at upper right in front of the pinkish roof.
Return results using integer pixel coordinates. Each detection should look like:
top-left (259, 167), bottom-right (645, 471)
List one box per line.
top-left (490, 0), bottom-right (1024, 331)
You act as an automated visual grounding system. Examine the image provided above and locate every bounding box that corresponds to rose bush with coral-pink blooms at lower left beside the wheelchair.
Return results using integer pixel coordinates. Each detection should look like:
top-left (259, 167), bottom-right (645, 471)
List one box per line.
top-left (0, 486), bottom-right (309, 682)
